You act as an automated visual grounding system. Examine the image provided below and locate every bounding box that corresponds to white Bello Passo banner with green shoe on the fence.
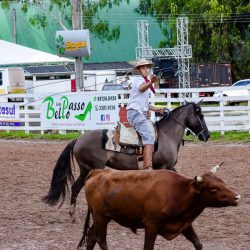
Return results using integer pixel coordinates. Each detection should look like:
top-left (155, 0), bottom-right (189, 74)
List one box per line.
top-left (42, 93), bottom-right (119, 130)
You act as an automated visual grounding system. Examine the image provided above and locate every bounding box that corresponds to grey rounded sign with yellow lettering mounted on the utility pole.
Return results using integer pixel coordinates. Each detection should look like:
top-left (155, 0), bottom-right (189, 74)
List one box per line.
top-left (56, 29), bottom-right (90, 57)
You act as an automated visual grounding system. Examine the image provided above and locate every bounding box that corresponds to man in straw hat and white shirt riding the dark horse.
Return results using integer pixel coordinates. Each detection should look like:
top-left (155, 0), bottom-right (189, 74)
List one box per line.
top-left (127, 59), bottom-right (164, 169)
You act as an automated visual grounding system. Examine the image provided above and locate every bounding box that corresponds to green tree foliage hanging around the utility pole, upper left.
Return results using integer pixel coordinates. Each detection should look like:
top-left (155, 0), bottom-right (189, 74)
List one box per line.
top-left (1, 0), bottom-right (125, 42)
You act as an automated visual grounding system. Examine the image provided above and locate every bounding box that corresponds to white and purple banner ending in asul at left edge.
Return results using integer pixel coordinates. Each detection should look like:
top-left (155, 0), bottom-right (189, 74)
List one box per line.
top-left (0, 103), bottom-right (20, 126)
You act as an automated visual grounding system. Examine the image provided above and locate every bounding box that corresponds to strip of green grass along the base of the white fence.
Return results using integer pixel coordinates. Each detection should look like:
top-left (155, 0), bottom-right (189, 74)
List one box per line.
top-left (0, 131), bottom-right (250, 143)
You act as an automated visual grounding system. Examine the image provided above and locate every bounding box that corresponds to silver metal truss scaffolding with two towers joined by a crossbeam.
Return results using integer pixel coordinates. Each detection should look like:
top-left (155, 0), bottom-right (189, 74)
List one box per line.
top-left (136, 17), bottom-right (192, 92)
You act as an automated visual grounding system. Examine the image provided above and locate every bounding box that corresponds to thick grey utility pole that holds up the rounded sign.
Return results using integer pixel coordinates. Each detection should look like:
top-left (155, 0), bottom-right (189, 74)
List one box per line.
top-left (72, 0), bottom-right (84, 91)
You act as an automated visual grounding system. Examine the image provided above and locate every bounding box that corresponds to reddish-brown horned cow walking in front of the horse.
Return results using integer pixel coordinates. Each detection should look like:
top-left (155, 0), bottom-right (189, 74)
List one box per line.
top-left (78, 165), bottom-right (240, 250)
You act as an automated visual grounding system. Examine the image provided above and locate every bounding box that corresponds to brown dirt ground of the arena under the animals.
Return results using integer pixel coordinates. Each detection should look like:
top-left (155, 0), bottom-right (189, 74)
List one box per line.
top-left (0, 140), bottom-right (250, 250)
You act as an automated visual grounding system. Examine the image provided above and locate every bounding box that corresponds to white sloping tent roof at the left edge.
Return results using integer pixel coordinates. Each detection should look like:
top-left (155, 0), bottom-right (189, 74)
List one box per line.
top-left (0, 40), bottom-right (72, 66)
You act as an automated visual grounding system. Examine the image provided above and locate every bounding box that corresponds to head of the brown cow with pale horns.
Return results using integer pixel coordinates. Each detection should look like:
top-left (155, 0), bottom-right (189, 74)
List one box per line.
top-left (192, 162), bottom-right (241, 207)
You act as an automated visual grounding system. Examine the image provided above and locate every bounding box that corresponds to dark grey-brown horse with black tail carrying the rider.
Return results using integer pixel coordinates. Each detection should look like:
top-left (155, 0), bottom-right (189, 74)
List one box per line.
top-left (42, 102), bottom-right (210, 222)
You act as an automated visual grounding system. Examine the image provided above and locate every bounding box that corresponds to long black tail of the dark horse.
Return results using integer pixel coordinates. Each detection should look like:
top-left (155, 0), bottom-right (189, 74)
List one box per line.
top-left (42, 139), bottom-right (76, 207)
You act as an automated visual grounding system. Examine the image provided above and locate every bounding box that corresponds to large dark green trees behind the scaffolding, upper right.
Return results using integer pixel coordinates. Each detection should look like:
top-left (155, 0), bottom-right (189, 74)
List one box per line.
top-left (137, 0), bottom-right (250, 80)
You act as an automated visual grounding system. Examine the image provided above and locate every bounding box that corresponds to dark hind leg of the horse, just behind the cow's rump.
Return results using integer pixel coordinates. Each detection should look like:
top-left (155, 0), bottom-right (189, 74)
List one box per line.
top-left (69, 167), bottom-right (89, 223)
